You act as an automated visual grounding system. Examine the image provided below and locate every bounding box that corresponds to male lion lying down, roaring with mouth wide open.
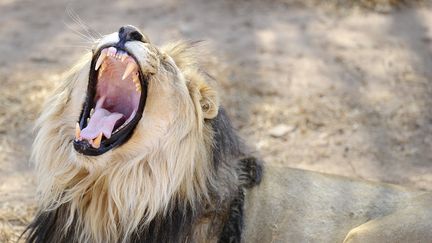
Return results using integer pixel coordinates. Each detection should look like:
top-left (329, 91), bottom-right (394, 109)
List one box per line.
top-left (24, 25), bottom-right (432, 242)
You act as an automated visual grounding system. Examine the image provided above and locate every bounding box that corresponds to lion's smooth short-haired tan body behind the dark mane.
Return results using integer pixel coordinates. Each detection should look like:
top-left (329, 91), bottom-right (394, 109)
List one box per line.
top-left (243, 166), bottom-right (432, 243)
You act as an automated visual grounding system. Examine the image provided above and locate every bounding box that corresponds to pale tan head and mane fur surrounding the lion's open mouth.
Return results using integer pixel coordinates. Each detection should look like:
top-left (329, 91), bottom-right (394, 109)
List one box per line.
top-left (33, 35), bottom-right (219, 242)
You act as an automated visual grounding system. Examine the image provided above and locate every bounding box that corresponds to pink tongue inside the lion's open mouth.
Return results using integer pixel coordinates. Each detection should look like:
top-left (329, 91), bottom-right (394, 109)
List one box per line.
top-left (81, 98), bottom-right (123, 140)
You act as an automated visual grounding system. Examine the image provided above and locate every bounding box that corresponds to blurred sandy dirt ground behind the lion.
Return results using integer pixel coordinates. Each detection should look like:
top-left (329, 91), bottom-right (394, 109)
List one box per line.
top-left (0, 0), bottom-right (432, 242)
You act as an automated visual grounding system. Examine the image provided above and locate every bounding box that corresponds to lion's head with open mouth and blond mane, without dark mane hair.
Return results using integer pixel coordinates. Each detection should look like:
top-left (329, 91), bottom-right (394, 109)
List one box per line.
top-left (33, 26), bottom-right (223, 242)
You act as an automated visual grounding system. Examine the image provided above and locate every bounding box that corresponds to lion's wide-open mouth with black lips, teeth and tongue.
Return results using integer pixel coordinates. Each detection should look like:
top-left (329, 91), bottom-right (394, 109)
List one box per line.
top-left (74, 46), bottom-right (147, 155)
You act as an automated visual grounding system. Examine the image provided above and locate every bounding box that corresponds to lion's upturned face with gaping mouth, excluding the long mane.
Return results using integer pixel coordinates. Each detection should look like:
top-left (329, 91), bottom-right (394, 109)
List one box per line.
top-left (66, 26), bottom-right (217, 159)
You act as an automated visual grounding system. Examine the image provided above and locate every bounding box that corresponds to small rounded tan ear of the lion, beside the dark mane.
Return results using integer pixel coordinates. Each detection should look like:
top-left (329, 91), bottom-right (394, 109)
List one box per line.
top-left (198, 84), bottom-right (219, 119)
